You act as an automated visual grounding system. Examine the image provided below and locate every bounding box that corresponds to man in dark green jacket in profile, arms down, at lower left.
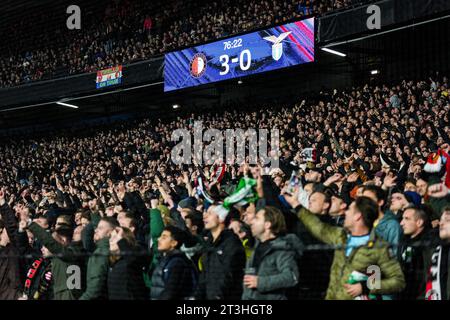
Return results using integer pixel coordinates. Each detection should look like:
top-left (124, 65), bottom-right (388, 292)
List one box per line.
top-left (80, 217), bottom-right (119, 300)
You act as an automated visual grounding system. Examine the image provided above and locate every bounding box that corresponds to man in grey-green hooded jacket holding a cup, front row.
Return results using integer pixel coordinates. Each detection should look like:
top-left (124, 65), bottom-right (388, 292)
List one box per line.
top-left (242, 207), bottom-right (303, 300)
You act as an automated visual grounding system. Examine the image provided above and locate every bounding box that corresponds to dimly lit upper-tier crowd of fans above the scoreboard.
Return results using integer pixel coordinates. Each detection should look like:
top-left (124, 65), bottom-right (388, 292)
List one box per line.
top-left (0, 0), bottom-right (370, 87)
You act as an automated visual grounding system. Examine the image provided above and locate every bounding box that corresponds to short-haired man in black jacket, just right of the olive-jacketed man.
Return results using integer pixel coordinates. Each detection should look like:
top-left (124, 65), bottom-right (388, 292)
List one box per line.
top-left (398, 207), bottom-right (437, 300)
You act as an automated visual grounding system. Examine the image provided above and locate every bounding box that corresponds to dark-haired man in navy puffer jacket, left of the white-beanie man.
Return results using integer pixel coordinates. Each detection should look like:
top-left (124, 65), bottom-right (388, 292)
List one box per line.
top-left (151, 226), bottom-right (197, 300)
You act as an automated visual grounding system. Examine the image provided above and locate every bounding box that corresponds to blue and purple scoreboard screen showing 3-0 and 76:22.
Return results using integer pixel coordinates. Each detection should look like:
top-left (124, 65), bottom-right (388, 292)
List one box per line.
top-left (164, 18), bottom-right (314, 92)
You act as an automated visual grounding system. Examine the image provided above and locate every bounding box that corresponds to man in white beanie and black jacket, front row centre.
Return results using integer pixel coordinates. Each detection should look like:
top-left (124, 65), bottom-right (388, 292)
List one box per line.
top-left (195, 204), bottom-right (246, 300)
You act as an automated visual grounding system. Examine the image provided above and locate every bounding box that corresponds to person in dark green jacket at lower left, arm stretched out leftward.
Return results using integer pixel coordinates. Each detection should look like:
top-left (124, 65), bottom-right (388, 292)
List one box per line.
top-left (19, 221), bottom-right (86, 300)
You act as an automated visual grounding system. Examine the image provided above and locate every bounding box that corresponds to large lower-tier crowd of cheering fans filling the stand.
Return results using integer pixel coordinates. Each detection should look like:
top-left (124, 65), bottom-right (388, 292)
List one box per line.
top-left (0, 75), bottom-right (450, 300)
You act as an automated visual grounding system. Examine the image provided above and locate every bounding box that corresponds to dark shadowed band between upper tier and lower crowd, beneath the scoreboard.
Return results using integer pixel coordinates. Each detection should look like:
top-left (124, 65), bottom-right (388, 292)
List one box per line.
top-left (0, 10), bottom-right (450, 129)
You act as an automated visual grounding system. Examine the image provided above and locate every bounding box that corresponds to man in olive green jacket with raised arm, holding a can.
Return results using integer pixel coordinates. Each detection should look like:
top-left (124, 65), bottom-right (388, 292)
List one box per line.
top-left (285, 195), bottom-right (405, 300)
